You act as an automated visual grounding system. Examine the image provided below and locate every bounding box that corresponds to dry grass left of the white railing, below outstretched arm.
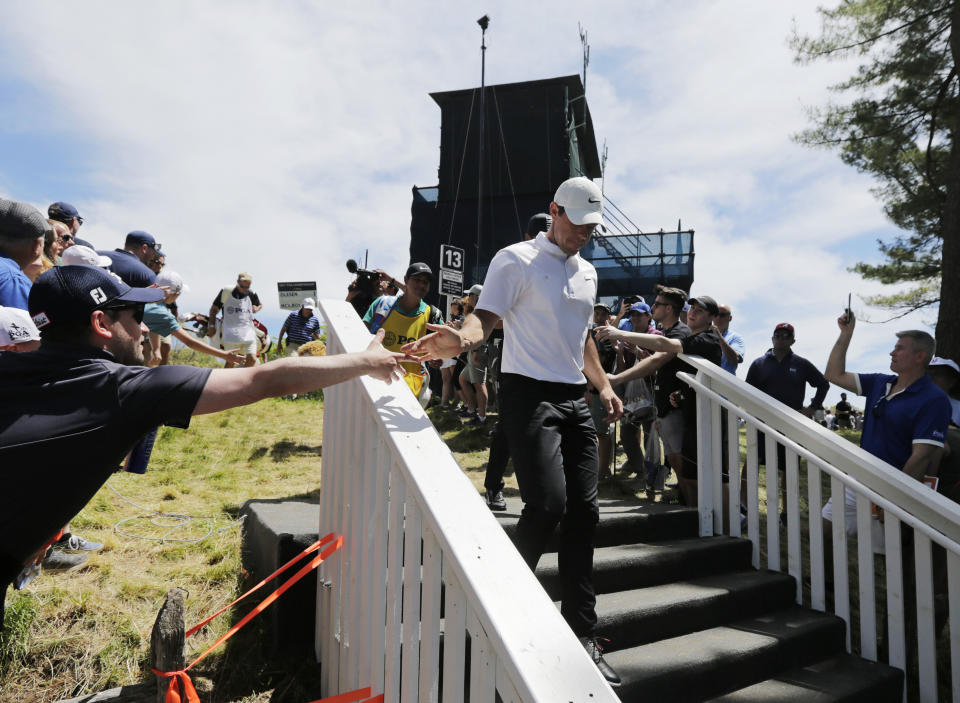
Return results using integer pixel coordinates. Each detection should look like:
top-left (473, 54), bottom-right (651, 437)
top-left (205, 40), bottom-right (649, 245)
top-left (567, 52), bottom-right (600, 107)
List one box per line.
top-left (0, 380), bottom-right (323, 701)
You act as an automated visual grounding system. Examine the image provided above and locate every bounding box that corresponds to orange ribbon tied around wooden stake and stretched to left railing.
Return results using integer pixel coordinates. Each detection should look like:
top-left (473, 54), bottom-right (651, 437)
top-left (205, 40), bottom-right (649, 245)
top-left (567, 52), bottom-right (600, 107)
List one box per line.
top-left (151, 532), bottom-right (344, 703)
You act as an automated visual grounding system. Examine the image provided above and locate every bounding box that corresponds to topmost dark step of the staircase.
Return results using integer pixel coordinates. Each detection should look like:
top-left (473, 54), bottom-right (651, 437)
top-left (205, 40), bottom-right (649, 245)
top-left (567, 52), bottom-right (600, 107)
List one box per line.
top-left (494, 498), bottom-right (698, 552)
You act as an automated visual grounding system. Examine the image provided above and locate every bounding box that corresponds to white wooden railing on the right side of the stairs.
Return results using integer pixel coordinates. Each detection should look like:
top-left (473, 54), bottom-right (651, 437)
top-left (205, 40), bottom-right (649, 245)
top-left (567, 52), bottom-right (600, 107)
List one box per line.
top-left (679, 356), bottom-right (960, 702)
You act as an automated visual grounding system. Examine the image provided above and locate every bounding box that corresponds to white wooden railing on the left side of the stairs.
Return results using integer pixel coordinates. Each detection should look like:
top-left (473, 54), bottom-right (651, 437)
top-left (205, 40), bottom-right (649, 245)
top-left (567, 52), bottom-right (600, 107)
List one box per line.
top-left (316, 301), bottom-right (618, 703)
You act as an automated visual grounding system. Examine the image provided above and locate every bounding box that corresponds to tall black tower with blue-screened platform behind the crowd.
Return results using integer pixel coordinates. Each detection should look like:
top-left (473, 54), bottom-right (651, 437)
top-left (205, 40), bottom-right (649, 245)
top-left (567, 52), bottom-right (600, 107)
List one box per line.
top-left (410, 75), bottom-right (693, 305)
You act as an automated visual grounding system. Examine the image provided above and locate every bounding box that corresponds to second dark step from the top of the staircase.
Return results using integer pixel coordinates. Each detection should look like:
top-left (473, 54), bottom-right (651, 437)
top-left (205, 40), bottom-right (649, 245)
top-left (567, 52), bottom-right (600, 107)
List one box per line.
top-left (537, 537), bottom-right (752, 600)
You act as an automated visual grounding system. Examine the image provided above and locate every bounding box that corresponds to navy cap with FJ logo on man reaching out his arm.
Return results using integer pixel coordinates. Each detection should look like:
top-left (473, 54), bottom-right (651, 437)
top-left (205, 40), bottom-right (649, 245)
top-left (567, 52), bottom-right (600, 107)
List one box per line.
top-left (29, 265), bottom-right (166, 330)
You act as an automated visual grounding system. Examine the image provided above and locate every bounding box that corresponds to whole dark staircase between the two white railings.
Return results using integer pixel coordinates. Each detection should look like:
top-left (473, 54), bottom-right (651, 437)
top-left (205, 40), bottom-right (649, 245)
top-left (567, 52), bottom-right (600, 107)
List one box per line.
top-left (497, 499), bottom-right (903, 703)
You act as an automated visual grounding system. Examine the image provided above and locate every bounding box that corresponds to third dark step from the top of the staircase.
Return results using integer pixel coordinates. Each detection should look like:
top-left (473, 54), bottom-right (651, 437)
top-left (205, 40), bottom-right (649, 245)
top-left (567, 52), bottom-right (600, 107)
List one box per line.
top-left (596, 569), bottom-right (795, 652)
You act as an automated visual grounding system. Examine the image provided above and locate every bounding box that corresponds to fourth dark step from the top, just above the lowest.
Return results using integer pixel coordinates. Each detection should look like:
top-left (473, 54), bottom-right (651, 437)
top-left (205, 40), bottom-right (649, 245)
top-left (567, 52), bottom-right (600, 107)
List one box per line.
top-left (605, 607), bottom-right (844, 703)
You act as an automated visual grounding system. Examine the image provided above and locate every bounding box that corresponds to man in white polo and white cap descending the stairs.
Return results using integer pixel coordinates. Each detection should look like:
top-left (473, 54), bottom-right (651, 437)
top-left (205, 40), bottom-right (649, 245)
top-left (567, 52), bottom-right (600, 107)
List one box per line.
top-left (403, 178), bottom-right (623, 686)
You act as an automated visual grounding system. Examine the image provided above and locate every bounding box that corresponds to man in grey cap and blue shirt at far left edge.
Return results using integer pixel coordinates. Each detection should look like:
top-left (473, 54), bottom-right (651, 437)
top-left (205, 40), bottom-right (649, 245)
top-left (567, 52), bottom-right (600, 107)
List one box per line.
top-left (0, 198), bottom-right (50, 310)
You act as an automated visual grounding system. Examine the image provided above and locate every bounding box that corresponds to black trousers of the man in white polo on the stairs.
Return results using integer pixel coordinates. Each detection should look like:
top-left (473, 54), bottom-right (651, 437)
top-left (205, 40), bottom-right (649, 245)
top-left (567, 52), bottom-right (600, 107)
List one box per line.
top-left (501, 374), bottom-right (600, 636)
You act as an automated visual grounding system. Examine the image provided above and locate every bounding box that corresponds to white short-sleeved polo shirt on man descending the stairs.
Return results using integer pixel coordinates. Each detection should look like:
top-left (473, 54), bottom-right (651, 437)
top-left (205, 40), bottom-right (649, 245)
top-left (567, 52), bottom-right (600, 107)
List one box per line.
top-left (477, 232), bottom-right (597, 383)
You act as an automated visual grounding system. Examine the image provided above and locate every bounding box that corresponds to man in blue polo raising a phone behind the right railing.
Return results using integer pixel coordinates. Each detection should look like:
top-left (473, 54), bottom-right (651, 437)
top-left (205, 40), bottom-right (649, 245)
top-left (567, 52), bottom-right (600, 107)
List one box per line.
top-left (823, 311), bottom-right (950, 533)
